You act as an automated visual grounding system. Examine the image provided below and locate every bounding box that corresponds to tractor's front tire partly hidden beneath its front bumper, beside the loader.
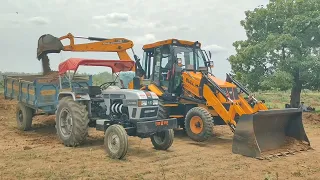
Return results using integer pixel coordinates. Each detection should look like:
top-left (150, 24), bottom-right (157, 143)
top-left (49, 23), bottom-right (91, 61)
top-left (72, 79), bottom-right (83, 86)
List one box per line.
top-left (150, 129), bottom-right (174, 150)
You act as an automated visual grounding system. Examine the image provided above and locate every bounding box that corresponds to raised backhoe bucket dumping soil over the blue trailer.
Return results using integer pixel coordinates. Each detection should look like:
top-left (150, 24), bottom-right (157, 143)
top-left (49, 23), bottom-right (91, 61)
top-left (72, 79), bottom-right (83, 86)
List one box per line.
top-left (37, 34), bottom-right (63, 60)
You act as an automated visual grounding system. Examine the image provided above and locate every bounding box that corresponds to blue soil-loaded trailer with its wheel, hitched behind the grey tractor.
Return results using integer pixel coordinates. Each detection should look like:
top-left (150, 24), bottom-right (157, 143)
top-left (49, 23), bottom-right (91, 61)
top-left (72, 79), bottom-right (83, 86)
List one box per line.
top-left (3, 74), bottom-right (92, 131)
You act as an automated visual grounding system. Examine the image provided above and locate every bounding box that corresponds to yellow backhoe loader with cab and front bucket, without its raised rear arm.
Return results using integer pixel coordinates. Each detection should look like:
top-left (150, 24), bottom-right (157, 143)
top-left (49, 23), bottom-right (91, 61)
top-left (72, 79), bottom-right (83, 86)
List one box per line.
top-left (129, 39), bottom-right (310, 157)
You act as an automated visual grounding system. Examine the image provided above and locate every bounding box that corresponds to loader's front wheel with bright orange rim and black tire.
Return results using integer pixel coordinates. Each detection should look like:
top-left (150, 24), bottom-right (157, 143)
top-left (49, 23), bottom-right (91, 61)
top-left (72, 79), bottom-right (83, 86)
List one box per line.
top-left (185, 107), bottom-right (213, 142)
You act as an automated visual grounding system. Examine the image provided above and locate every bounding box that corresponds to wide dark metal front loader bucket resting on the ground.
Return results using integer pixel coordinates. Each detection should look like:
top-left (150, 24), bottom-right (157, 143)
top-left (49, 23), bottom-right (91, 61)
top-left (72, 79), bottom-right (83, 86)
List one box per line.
top-left (232, 108), bottom-right (310, 158)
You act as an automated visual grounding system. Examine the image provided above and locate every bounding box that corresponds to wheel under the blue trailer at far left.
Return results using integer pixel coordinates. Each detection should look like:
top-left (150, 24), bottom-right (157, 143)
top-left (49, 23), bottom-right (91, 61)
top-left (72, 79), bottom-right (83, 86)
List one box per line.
top-left (16, 102), bottom-right (33, 131)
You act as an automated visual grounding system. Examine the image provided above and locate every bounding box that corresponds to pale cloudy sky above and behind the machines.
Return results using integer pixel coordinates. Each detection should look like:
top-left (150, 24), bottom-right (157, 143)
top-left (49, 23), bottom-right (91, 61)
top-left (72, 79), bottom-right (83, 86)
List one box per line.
top-left (0, 0), bottom-right (268, 79)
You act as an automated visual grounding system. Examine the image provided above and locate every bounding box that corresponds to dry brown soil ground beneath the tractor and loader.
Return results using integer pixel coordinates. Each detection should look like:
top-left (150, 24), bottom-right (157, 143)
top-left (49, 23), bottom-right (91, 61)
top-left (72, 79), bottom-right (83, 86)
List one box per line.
top-left (0, 95), bottom-right (320, 180)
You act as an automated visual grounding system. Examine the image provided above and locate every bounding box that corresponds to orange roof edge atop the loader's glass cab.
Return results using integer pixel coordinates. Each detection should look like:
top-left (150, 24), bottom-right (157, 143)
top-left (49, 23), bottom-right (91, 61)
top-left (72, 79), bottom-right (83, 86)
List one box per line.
top-left (142, 39), bottom-right (201, 50)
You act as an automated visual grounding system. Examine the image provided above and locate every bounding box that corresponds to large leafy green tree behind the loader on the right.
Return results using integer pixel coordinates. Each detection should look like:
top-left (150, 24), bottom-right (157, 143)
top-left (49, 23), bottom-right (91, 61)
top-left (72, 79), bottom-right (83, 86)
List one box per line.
top-left (228, 0), bottom-right (320, 107)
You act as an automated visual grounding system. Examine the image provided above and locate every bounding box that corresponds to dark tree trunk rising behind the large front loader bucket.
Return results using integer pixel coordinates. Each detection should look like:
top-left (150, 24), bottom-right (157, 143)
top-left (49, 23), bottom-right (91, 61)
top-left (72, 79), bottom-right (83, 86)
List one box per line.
top-left (290, 71), bottom-right (302, 108)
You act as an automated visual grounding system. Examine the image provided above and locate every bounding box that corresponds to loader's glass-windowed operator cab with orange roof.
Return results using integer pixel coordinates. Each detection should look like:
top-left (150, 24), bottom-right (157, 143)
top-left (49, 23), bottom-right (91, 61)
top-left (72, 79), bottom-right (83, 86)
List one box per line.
top-left (141, 39), bottom-right (212, 101)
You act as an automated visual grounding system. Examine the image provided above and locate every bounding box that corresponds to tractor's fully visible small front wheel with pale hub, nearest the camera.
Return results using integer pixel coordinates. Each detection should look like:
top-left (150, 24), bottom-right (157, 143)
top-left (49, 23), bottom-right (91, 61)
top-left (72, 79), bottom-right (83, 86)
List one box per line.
top-left (104, 124), bottom-right (129, 159)
